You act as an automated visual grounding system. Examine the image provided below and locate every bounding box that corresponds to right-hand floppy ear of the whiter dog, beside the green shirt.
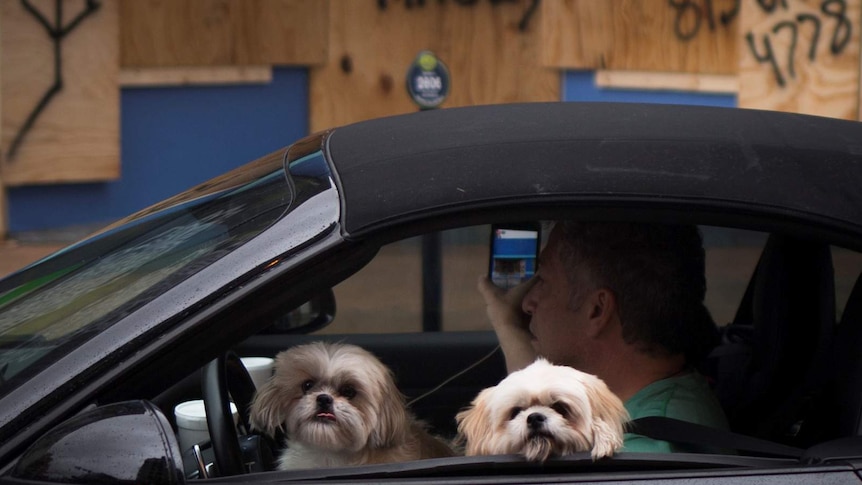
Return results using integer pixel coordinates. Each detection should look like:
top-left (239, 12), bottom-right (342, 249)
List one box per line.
top-left (586, 378), bottom-right (629, 460)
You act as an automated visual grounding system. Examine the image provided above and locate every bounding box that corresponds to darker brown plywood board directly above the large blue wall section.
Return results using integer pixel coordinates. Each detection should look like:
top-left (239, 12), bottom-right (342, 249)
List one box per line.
top-left (123, 0), bottom-right (329, 67)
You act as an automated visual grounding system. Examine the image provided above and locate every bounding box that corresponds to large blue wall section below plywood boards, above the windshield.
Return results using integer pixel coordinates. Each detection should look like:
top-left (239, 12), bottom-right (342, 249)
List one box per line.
top-left (8, 68), bottom-right (308, 233)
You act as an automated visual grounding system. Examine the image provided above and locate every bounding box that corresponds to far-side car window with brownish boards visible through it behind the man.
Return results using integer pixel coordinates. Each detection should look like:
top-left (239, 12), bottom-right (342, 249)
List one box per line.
top-left (322, 225), bottom-right (768, 333)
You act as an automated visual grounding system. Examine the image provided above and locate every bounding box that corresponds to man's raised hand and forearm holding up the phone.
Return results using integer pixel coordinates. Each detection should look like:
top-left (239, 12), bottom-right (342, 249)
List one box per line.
top-left (478, 275), bottom-right (538, 373)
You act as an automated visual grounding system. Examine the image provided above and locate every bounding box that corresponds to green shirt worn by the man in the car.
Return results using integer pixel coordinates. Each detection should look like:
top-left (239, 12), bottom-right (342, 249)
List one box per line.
top-left (622, 371), bottom-right (728, 453)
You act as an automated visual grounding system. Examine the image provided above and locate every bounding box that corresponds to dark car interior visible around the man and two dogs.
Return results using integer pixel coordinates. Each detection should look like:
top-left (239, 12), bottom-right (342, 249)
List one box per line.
top-left (10, 225), bottom-right (862, 479)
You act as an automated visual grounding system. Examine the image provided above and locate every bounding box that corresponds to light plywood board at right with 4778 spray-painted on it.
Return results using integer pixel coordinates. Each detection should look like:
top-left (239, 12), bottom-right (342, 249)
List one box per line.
top-left (739, 0), bottom-right (860, 120)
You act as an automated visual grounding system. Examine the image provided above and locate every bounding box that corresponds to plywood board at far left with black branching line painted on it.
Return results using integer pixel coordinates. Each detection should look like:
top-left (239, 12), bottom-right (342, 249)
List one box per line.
top-left (0, 0), bottom-right (120, 185)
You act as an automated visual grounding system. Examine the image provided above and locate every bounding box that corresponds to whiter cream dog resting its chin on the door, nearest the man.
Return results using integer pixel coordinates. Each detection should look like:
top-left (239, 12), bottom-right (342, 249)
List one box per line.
top-left (456, 359), bottom-right (629, 461)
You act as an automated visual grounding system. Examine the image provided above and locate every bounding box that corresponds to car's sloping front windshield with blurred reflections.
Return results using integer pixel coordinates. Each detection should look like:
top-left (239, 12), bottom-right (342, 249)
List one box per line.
top-left (0, 151), bottom-right (293, 395)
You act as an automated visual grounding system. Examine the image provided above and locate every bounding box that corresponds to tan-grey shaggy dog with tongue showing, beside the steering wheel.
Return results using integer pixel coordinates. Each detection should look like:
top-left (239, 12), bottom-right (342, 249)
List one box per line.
top-left (251, 342), bottom-right (453, 470)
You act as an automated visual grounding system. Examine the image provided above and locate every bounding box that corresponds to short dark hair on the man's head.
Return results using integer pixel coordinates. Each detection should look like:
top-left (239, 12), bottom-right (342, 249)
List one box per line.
top-left (557, 221), bottom-right (718, 362)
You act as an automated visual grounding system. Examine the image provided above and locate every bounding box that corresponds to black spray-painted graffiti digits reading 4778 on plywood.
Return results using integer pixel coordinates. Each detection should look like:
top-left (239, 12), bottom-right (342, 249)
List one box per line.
top-left (745, 0), bottom-right (853, 87)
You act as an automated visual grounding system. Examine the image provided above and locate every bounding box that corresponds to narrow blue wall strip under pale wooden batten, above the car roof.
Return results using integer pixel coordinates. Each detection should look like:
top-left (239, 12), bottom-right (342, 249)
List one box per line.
top-left (563, 71), bottom-right (736, 108)
